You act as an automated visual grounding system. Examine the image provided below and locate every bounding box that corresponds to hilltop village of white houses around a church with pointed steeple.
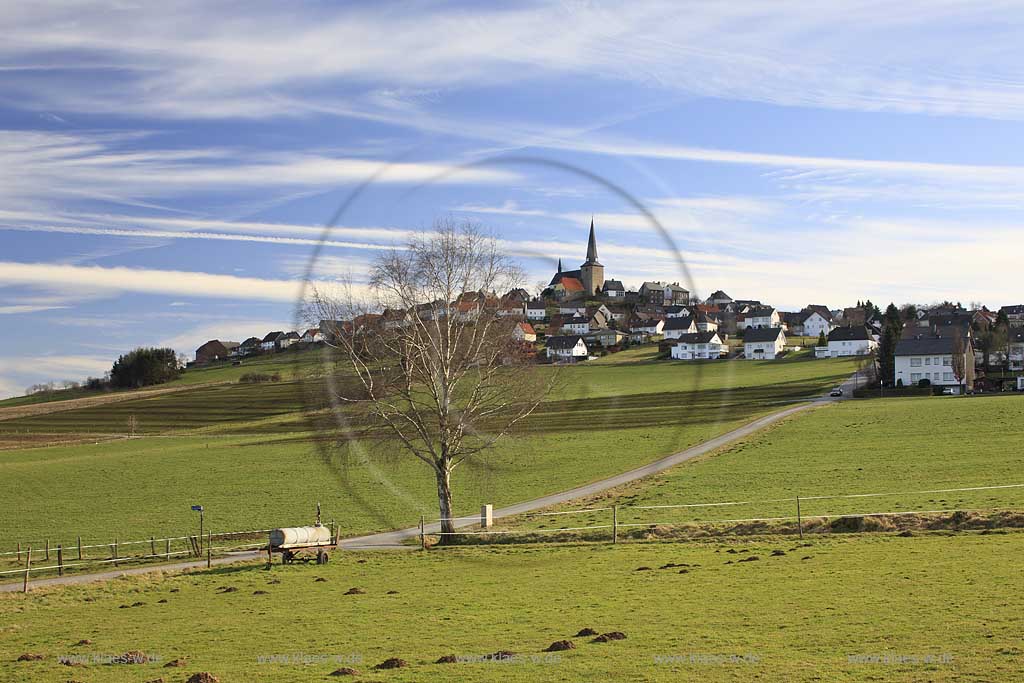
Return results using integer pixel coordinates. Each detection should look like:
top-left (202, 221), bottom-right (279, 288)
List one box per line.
top-left (189, 220), bottom-right (1024, 393)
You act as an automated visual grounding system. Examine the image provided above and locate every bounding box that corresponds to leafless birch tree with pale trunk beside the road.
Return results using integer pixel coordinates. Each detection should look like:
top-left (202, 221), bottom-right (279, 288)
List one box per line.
top-left (311, 220), bottom-right (555, 543)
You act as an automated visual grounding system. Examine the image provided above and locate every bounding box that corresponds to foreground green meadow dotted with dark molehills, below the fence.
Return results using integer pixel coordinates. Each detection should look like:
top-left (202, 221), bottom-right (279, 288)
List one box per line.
top-left (0, 532), bottom-right (1024, 683)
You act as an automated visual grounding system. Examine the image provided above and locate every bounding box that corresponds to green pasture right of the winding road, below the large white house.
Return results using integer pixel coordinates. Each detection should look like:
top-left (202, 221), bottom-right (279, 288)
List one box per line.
top-left (515, 394), bottom-right (1024, 526)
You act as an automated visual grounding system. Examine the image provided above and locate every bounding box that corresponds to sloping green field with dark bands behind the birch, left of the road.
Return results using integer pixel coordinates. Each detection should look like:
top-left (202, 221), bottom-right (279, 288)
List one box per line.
top-left (0, 360), bottom-right (852, 548)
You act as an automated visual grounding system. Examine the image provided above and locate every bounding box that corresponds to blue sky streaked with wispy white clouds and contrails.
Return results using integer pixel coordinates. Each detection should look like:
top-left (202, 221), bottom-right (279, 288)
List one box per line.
top-left (0, 0), bottom-right (1024, 396)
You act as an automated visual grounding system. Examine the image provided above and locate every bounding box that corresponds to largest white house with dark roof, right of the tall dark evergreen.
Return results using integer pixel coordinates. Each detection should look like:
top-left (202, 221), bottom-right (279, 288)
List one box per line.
top-left (895, 334), bottom-right (974, 393)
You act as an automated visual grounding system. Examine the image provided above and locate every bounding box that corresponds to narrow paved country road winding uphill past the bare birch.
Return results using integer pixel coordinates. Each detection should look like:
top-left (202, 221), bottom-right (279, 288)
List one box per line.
top-left (0, 385), bottom-right (856, 593)
